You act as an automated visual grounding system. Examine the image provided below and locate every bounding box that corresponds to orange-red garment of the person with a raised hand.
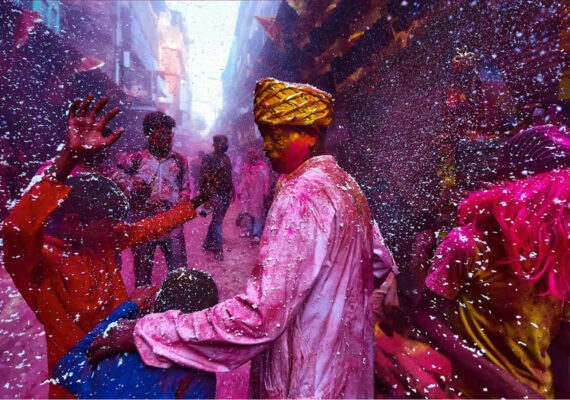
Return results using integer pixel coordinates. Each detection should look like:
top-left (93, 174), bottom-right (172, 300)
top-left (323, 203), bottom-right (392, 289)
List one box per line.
top-left (2, 180), bottom-right (196, 397)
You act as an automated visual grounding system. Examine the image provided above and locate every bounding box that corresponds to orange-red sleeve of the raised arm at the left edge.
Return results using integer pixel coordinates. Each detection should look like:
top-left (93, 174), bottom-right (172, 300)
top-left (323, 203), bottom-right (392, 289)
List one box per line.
top-left (2, 179), bottom-right (71, 302)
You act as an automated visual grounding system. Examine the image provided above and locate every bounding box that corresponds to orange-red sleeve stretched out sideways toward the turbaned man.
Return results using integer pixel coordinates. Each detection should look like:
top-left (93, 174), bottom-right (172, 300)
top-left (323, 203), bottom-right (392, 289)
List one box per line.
top-left (111, 201), bottom-right (196, 250)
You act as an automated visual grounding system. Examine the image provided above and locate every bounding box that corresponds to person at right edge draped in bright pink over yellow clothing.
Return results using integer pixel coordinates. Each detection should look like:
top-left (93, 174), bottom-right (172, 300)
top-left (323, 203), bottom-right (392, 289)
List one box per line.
top-left (416, 125), bottom-right (570, 398)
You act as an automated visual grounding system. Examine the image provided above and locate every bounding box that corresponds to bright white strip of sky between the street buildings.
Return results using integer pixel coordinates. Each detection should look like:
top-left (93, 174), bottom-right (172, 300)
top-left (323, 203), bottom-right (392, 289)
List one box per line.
top-left (167, 0), bottom-right (240, 134)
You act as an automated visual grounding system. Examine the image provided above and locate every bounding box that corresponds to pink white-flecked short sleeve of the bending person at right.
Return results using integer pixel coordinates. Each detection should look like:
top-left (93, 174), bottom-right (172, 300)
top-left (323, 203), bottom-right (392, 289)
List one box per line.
top-left (426, 226), bottom-right (477, 300)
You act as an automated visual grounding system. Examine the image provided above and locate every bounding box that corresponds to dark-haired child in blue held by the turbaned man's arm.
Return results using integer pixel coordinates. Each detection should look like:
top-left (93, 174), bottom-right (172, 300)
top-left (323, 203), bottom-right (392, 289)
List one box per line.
top-left (53, 269), bottom-right (218, 399)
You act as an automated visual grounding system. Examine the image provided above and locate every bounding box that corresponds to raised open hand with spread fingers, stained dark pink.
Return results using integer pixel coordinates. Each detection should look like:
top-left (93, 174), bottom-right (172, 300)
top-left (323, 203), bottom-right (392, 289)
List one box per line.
top-left (67, 94), bottom-right (124, 157)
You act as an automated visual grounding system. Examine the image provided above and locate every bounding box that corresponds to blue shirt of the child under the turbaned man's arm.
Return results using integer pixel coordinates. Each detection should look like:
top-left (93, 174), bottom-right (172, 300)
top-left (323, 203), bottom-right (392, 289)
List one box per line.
top-left (53, 301), bottom-right (216, 399)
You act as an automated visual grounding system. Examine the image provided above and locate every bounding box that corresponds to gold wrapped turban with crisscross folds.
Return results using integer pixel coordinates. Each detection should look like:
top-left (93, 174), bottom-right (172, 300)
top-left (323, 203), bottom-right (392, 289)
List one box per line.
top-left (253, 78), bottom-right (334, 126)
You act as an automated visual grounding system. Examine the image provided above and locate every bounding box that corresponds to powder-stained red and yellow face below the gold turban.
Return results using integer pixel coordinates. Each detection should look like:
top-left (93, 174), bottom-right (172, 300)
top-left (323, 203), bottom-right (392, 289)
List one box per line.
top-left (259, 125), bottom-right (316, 174)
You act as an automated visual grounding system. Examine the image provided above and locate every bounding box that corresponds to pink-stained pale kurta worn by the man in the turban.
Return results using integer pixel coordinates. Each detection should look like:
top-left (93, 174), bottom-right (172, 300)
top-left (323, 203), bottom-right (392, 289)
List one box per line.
top-left (131, 156), bottom-right (384, 398)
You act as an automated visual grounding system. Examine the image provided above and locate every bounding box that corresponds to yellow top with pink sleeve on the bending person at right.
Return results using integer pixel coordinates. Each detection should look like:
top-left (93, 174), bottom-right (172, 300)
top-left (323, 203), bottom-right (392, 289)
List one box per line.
top-left (426, 226), bottom-right (570, 398)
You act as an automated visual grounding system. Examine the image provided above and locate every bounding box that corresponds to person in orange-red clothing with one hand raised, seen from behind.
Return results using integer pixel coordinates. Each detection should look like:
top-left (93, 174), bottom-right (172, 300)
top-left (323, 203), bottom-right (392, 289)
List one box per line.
top-left (2, 95), bottom-right (207, 398)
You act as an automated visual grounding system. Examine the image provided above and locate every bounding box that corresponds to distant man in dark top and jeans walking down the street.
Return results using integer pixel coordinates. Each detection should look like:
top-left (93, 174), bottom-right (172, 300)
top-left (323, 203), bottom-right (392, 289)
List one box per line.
top-left (200, 135), bottom-right (236, 261)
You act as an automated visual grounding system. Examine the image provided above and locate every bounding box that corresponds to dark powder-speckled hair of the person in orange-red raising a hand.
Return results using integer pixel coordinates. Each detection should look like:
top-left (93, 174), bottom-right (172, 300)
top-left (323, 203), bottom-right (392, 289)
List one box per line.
top-left (52, 174), bottom-right (129, 221)
